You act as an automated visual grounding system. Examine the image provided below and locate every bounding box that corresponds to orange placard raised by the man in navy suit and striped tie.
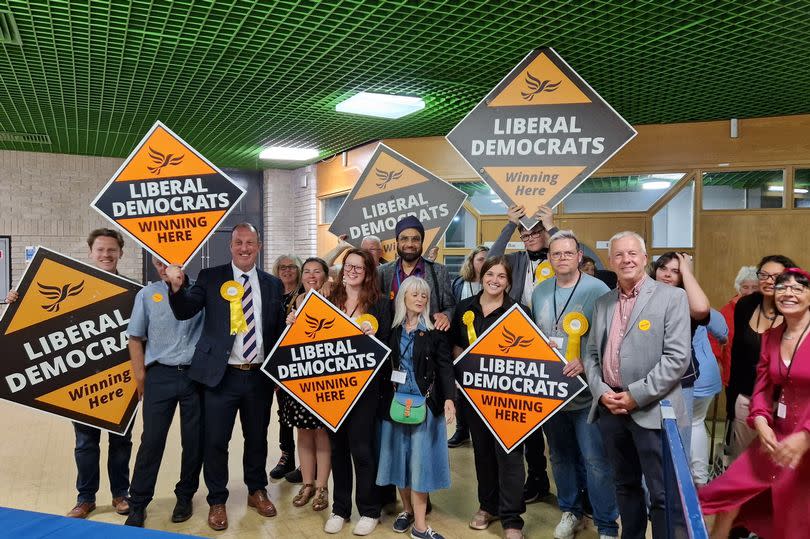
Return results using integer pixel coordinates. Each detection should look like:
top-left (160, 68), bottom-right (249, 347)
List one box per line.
top-left (90, 122), bottom-right (245, 266)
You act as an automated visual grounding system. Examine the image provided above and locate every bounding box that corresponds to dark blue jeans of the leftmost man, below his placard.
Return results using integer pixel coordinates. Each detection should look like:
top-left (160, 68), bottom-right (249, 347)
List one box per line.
top-left (73, 423), bottom-right (132, 503)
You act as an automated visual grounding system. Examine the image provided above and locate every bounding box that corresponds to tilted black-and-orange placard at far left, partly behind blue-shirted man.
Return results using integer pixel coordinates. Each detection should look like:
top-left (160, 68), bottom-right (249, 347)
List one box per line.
top-left (0, 247), bottom-right (141, 434)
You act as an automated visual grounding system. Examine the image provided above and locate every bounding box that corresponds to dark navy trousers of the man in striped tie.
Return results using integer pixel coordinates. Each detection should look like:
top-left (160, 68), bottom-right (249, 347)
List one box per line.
top-left (203, 367), bottom-right (273, 505)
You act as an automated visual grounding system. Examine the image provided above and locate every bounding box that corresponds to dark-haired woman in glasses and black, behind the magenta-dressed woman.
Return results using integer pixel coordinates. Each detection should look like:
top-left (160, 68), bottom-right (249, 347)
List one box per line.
top-left (726, 255), bottom-right (796, 459)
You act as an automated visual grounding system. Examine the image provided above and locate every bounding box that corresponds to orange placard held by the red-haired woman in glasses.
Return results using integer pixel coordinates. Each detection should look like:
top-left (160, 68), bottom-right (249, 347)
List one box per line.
top-left (262, 290), bottom-right (391, 432)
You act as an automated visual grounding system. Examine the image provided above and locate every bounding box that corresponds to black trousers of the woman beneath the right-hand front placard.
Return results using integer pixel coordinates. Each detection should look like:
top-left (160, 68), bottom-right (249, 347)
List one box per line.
top-left (465, 406), bottom-right (526, 530)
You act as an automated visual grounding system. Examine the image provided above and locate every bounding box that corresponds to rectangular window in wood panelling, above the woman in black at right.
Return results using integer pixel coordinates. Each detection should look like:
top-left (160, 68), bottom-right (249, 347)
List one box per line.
top-left (702, 170), bottom-right (785, 210)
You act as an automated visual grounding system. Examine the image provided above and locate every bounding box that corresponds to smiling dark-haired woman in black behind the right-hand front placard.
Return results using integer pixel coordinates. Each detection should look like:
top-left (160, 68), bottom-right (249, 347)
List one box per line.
top-left (450, 256), bottom-right (528, 539)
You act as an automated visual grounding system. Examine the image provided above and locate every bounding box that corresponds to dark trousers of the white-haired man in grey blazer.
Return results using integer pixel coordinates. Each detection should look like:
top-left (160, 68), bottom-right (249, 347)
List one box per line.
top-left (598, 406), bottom-right (667, 539)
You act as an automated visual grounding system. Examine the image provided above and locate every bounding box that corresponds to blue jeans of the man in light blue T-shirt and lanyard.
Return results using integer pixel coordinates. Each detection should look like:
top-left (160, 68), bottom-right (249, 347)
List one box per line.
top-left (543, 408), bottom-right (619, 537)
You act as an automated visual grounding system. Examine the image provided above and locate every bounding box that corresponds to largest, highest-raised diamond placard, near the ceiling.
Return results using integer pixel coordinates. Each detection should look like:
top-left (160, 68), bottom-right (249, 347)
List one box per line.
top-left (447, 47), bottom-right (636, 228)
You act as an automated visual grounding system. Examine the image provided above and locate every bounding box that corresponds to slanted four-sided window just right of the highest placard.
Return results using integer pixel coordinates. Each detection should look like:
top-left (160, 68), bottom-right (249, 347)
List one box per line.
top-left (564, 172), bottom-right (685, 213)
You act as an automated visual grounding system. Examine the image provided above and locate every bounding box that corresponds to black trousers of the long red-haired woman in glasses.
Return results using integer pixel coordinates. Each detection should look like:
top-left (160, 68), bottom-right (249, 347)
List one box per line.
top-left (330, 390), bottom-right (383, 518)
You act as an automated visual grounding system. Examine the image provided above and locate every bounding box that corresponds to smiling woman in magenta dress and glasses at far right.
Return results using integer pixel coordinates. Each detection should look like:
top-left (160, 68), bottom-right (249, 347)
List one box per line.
top-left (699, 268), bottom-right (810, 539)
